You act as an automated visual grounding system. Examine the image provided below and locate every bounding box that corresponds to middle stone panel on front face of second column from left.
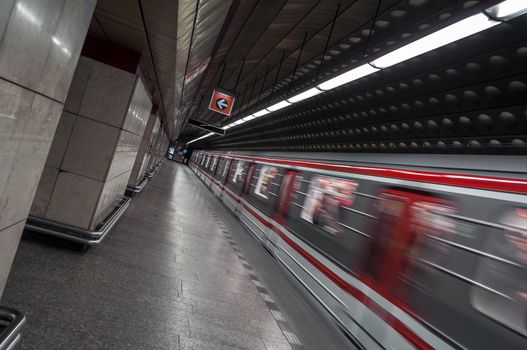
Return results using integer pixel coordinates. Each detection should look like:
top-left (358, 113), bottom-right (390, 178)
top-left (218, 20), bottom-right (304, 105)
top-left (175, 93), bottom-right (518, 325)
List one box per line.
top-left (61, 115), bottom-right (120, 181)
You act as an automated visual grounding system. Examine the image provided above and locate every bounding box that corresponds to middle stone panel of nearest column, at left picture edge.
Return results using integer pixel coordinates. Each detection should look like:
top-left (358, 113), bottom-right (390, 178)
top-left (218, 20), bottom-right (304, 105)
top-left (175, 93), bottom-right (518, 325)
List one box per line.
top-left (0, 79), bottom-right (62, 229)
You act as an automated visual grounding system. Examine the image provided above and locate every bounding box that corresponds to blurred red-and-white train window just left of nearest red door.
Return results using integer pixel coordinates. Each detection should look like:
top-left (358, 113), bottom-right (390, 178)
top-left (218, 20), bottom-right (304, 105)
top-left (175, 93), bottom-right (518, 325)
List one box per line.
top-left (300, 176), bottom-right (358, 236)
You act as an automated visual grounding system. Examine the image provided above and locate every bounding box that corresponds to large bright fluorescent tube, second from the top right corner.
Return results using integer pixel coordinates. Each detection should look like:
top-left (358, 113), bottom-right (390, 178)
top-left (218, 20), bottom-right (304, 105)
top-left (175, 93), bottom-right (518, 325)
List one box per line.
top-left (371, 13), bottom-right (500, 68)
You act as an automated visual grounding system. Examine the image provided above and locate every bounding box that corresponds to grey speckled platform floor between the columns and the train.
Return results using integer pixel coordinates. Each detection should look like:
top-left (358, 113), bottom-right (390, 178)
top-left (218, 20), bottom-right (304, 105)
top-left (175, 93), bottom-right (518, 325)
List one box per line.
top-left (1, 162), bottom-right (352, 350)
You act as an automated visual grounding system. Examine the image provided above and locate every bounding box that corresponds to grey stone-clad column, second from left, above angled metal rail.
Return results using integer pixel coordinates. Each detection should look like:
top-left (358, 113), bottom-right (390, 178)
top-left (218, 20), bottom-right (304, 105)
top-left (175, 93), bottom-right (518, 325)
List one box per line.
top-left (31, 38), bottom-right (152, 230)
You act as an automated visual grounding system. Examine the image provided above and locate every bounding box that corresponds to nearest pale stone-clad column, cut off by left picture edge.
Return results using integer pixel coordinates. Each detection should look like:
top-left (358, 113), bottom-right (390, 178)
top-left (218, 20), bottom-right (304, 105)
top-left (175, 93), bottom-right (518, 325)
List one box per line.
top-left (0, 0), bottom-right (96, 295)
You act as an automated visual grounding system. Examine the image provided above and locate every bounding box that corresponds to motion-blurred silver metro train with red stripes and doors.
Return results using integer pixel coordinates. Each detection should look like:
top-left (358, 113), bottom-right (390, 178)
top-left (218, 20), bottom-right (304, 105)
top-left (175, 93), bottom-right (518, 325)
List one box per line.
top-left (190, 151), bottom-right (527, 349)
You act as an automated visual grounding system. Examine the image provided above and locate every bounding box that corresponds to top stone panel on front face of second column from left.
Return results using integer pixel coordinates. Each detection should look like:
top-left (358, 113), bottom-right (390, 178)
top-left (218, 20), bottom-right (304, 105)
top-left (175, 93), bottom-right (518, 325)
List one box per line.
top-left (79, 61), bottom-right (136, 128)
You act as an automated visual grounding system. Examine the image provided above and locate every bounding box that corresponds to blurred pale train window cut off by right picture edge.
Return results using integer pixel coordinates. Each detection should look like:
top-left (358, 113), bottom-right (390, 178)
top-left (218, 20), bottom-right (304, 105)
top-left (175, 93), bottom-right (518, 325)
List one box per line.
top-left (471, 208), bottom-right (527, 336)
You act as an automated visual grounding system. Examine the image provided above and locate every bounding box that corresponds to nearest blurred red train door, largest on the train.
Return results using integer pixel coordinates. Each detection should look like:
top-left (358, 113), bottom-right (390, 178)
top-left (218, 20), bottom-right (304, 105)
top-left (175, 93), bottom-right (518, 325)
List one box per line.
top-left (362, 189), bottom-right (455, 315)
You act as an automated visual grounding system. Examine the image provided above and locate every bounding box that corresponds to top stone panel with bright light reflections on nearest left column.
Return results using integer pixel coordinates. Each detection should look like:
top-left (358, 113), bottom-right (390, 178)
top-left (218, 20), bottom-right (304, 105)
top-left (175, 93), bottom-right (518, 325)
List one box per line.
top-left (0, 0), bottom-right (96, 102)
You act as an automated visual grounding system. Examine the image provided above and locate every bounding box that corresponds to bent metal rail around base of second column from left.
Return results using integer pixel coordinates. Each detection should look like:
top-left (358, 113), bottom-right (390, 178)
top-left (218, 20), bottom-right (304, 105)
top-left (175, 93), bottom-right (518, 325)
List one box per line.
top-left (26, 197), bottom-right (131, 246)
